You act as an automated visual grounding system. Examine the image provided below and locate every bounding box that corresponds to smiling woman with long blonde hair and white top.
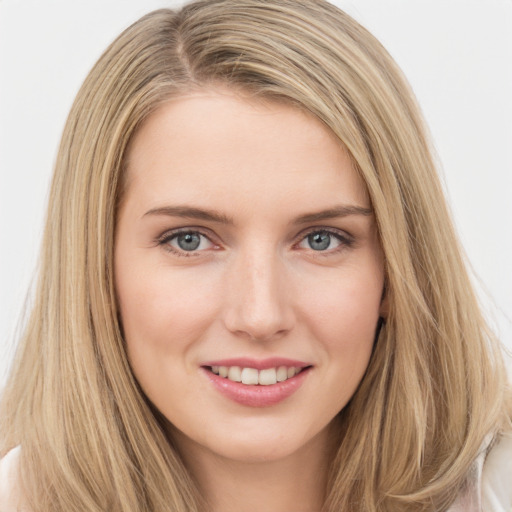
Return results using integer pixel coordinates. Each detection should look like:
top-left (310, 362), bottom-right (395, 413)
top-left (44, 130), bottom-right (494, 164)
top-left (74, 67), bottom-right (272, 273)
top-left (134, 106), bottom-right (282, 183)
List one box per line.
top-left (0, 0), bottom-right (512, 511)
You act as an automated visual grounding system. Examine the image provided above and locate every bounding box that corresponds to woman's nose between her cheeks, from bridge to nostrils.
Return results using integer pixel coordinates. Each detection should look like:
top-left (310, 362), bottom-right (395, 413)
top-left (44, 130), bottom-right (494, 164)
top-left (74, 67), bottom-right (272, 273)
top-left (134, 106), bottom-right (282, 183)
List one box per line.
top-left (224, 250), bottom-right (295, 341)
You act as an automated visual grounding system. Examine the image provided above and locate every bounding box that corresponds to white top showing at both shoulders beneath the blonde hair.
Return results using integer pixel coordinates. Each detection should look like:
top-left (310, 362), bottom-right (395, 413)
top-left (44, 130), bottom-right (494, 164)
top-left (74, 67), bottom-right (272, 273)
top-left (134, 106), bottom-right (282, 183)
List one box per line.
top-left (0, 434), bottom-right (512, 512)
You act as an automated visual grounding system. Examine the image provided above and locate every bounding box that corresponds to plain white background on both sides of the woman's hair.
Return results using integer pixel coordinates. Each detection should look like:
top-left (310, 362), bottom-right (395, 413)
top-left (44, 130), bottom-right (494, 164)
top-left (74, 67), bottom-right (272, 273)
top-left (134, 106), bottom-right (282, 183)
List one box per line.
top-left (0, 0), bottom-right (512, 387)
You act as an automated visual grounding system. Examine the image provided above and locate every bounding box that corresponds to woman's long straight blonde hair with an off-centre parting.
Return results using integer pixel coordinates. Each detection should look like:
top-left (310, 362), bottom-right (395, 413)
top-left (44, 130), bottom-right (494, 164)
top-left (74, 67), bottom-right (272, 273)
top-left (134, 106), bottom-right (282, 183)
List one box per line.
top-left (0, 0), bottom-right (509, 512)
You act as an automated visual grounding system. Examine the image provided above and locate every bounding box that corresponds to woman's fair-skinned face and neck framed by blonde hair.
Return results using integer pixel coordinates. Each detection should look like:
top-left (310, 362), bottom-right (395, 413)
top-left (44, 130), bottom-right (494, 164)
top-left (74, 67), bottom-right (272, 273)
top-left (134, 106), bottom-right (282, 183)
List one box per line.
top-left (115, 88), bottom-right (384, 512)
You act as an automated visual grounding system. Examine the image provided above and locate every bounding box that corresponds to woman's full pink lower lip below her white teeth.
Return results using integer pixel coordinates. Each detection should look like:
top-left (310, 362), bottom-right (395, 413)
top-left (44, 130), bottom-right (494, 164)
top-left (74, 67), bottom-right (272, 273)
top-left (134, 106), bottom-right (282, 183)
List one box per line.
top-left (201, 368), bottom-right (311, 407)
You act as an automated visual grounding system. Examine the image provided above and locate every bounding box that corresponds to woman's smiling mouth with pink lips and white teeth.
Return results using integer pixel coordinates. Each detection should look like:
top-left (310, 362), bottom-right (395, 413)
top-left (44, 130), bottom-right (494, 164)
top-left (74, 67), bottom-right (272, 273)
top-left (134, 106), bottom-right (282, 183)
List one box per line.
top-left (201, 359), bottom-right (312, 407)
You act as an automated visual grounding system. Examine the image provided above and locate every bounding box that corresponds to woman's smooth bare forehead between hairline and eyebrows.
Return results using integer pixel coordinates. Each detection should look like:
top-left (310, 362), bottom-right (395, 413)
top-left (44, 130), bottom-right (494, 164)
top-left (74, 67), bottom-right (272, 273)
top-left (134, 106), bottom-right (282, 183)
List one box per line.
top-left (126, 90), bottom-right (368, 216)
